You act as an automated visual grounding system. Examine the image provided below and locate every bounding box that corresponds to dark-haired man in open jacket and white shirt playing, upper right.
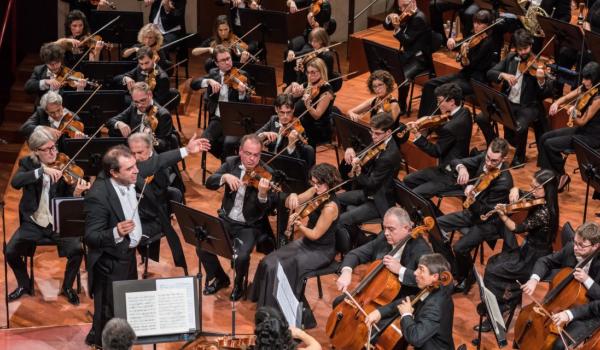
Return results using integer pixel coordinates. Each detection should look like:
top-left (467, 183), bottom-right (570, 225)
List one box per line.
top-left (475, 29), bottom-right (552, 166)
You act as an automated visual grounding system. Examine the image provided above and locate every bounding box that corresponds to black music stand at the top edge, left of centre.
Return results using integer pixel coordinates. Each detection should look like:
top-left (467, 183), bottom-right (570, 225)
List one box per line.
top-left (239, 8), bottom-right (309, 44)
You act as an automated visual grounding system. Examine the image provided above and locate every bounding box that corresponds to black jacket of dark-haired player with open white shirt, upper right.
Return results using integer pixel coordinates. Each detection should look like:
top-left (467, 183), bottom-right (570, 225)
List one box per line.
top-left (487, 52), bottom-right (552, 106)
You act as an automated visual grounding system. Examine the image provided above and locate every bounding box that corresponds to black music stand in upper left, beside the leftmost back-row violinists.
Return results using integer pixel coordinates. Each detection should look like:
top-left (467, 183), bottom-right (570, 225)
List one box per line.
top-left (80, 61), bottom-right (137, 91)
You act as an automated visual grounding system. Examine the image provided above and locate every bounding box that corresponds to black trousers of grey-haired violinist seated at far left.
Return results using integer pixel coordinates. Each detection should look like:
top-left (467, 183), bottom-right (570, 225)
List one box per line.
top-left (5, 221), bottom-right (83, 288)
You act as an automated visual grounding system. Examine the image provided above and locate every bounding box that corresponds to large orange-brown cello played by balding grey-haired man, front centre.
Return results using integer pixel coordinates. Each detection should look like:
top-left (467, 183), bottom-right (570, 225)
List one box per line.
top-left (325, 217), bottom-right (435, 350)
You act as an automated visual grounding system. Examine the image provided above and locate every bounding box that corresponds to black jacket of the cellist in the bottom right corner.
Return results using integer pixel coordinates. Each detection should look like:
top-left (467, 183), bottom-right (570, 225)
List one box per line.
top-left (531, 242), bottom-right (600, 300)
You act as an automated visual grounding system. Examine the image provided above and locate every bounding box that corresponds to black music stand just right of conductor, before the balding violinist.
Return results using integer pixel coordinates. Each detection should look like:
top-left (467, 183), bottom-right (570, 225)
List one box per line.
top-left (171, 201), bottom-right (237, 337)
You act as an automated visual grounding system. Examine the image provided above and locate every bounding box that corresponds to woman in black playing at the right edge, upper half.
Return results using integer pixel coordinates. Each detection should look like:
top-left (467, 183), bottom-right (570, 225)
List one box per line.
top-left (538, 62), bottom-right (600, 191)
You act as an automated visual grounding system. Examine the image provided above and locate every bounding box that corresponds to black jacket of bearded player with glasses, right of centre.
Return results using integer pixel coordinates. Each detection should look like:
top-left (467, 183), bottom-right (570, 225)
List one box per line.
top-left (450, 152), bottom-right (513, 222)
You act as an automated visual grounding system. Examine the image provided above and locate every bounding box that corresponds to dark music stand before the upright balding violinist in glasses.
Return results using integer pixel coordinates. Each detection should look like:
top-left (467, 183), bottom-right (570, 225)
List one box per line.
top-left (219, 101), bottom-right (274, 137)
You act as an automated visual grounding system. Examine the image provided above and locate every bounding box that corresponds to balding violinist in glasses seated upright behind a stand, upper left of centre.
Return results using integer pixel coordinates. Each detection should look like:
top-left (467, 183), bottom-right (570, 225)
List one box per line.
top-left (191, 45), bottom-right (250, 160)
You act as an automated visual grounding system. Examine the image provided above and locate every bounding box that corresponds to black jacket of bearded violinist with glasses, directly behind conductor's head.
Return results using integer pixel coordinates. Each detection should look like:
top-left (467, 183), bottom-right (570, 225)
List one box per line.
top-left (106, 101), bottom-right (174, 152)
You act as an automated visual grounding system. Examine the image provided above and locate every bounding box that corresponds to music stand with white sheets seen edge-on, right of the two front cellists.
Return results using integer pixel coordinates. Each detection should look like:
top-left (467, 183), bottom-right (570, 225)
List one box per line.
top-left (473, 266), bottom-right (508, 350)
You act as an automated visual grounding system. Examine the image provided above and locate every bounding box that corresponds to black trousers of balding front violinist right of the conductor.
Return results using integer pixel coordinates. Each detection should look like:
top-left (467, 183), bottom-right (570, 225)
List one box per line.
top-left (196, 220), bottom-right (255, 283)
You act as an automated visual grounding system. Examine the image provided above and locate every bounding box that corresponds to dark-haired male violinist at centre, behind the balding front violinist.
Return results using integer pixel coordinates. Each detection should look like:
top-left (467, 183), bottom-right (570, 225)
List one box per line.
top-left (256, 94), bottom-right (316, 169)
